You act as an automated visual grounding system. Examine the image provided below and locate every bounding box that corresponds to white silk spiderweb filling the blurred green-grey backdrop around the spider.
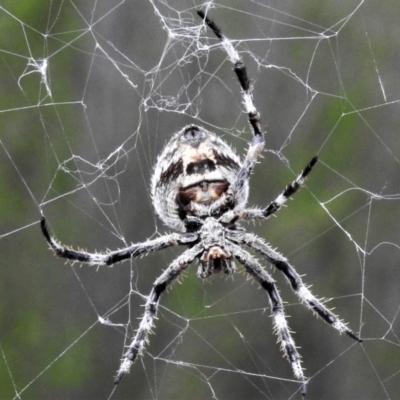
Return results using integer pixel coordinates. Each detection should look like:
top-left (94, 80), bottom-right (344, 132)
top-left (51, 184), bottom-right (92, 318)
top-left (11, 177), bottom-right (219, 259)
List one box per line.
top-left (0, 0), bottom-right (400, 399)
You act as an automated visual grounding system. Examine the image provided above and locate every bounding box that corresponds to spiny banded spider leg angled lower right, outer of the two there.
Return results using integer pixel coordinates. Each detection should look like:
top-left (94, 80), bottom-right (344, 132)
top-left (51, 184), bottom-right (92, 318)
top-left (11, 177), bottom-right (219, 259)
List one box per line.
top-left (227, 232), bottom-right (362, 342)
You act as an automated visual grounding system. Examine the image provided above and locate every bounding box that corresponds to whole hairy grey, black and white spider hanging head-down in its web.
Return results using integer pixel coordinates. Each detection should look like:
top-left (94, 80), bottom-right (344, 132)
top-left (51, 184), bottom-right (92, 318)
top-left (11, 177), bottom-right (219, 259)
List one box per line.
top-left (41, 10), bottom-right (361, 395)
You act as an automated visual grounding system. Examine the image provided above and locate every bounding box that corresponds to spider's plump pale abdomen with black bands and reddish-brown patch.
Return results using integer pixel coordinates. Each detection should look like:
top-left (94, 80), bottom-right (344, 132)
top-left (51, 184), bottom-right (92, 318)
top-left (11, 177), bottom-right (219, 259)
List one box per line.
top-left (151, 125), bottom-right (248, 231)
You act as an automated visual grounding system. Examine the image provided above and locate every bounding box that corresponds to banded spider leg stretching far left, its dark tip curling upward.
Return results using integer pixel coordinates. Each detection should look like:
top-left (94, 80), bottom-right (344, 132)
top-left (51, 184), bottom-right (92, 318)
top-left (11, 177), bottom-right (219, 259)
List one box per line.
top-left (40, 216), bottom-right (198, 265)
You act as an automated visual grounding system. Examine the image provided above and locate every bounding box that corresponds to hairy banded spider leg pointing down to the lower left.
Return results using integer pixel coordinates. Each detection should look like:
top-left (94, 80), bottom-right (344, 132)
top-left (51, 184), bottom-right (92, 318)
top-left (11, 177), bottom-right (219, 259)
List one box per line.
top-left (114, 243), bottom-right (204, 384)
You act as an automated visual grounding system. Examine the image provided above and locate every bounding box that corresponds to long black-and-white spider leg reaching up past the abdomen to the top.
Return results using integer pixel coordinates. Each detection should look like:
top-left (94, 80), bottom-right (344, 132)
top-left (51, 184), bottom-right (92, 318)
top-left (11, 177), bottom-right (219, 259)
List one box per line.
top-left (197, 10), bottom-right (264, 209)
